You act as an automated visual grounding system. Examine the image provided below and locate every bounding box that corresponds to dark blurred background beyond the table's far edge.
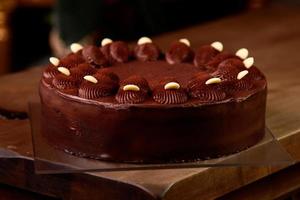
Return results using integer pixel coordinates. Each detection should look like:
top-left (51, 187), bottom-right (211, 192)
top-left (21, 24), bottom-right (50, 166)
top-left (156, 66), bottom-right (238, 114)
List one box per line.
top-left (0, 0), bottom-right (300, 76)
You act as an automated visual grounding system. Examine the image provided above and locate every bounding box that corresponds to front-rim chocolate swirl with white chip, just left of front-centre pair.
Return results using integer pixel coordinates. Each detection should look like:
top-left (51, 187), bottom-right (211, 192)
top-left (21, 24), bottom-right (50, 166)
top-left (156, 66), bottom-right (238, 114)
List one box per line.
top-left (78, 74), bottom-right (119, 99)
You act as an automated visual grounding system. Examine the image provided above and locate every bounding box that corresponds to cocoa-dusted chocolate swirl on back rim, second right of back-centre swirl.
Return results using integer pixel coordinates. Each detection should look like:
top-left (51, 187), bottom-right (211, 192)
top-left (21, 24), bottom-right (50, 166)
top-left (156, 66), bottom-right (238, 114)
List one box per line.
top-left (194, 45), bottom-right (220, 68)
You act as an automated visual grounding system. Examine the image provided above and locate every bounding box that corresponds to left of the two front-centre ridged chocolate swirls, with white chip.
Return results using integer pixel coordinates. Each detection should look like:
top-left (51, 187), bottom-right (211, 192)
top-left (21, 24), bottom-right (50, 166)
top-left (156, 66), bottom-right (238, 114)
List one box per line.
top-left (116, 76), bottom-right (149, 104)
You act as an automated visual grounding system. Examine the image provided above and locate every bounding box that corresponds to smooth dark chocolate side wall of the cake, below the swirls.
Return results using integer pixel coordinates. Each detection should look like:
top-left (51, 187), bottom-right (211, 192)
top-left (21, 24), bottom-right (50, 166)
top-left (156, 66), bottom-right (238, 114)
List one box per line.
top-left (40, 81), bottom-right (266, 163)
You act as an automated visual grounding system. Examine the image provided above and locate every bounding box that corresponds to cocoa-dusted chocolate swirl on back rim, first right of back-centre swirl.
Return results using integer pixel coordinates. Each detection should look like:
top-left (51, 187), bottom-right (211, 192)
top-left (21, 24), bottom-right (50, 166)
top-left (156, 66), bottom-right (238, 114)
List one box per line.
top-left (166, 41), bottom-right (193, 64)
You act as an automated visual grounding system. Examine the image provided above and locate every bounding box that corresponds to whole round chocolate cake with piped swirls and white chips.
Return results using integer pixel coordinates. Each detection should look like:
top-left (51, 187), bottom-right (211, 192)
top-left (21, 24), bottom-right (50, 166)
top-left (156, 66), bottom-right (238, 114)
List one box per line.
top-left (40, 37), bottom-right (267, 163)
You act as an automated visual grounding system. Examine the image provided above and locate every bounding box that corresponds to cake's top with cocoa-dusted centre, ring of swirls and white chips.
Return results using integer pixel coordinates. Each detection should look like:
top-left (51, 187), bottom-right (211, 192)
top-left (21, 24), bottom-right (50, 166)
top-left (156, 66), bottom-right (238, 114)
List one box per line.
top-left (42, 37), bottom-right (266, 106)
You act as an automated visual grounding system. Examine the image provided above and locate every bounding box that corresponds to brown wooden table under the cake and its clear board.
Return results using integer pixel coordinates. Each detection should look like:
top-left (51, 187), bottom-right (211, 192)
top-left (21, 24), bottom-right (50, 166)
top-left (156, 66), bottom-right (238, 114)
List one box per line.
top-left (0, 3), bottom-right (300, 199)
